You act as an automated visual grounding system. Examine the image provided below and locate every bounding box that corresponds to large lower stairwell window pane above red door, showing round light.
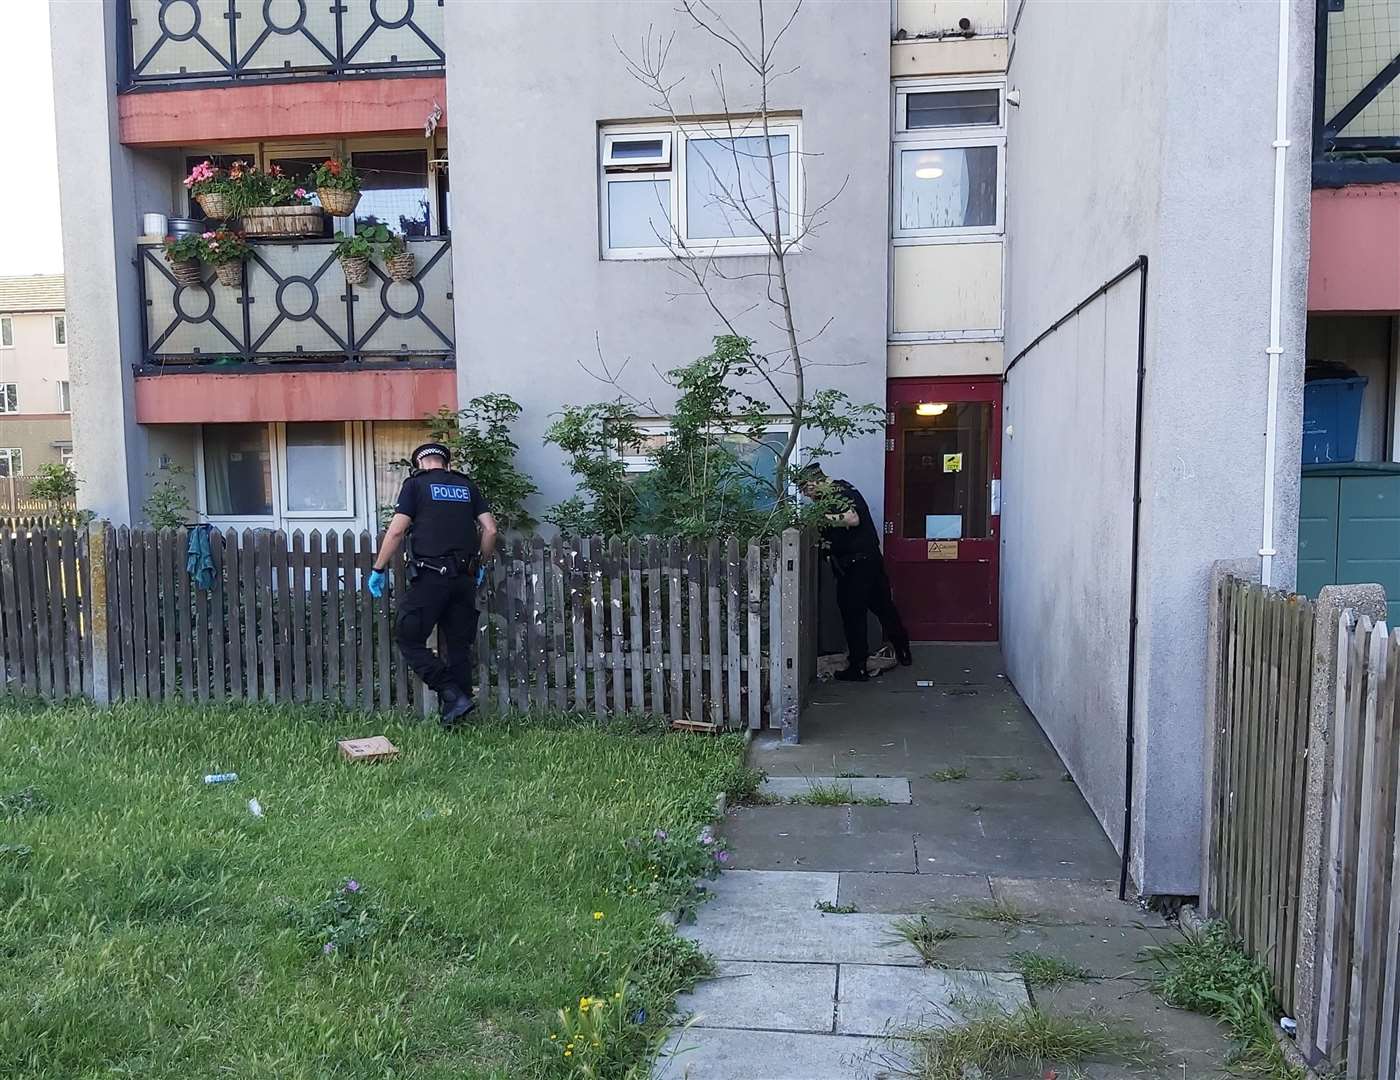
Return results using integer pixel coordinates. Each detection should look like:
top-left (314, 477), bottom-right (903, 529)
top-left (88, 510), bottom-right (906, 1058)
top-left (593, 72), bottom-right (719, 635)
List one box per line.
top-left (899, 146), bottom-right (997, 228)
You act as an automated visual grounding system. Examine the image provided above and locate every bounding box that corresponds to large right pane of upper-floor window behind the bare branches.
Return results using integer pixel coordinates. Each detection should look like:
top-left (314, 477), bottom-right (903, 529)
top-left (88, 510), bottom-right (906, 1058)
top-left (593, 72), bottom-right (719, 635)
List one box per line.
top-left (686, 134), bottom-right (792, 240)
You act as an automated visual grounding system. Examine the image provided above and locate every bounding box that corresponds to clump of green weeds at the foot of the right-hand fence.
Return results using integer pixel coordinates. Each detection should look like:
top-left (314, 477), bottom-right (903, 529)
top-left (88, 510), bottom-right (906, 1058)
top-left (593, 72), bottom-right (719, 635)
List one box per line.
top-left (1144, 922), bottom-right (1303, 1080)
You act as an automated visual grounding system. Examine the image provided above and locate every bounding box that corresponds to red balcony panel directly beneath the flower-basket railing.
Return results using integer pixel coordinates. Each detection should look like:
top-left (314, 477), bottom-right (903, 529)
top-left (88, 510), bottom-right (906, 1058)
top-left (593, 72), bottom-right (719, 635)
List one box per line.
top-left (136, 368), bottom-right (456, 424)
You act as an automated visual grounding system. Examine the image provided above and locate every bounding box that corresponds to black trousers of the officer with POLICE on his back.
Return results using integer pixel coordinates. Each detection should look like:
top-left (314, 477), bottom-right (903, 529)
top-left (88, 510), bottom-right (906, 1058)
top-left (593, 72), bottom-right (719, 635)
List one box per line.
top-left (395, 570), bottom-right (477, 695)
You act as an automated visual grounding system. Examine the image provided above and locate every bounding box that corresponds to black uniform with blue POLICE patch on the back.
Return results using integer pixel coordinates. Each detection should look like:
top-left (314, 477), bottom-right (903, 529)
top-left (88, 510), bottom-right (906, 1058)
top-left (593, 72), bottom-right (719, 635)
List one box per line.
top-left (393, 469), bottom-right (491, 696)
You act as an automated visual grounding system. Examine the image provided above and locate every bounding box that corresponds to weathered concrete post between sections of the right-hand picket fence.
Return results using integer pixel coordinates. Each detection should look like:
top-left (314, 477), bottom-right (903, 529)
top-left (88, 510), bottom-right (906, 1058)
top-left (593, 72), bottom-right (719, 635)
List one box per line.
top-left (1294, 586), bottom-right (1386, 1062)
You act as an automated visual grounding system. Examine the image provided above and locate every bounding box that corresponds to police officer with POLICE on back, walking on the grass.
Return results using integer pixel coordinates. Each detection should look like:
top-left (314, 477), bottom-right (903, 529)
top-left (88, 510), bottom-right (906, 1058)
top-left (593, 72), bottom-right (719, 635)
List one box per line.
top-left (370, 443), bottom-right (497, 728)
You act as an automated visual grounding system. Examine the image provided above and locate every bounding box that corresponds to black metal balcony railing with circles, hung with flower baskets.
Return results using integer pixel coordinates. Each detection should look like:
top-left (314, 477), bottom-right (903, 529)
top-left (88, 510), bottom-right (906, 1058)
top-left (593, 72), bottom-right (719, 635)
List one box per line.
top-left (137, 237), bottom-right (455, 373)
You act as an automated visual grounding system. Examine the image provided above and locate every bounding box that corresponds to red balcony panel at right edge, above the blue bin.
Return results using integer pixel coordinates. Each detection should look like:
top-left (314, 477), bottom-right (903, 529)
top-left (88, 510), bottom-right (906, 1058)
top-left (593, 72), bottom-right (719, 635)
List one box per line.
top-left (1308, 184), bottom-right (1400, 312)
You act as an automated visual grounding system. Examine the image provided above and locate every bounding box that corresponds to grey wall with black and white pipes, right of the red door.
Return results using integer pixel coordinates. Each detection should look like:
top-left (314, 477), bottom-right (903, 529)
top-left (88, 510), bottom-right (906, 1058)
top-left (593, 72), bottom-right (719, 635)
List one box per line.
top-left (1002, 0), bottom-right (1313, 894)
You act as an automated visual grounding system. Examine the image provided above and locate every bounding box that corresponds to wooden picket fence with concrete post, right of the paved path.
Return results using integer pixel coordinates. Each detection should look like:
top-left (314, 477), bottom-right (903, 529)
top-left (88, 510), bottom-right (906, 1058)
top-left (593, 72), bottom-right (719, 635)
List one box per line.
top-left (1201, 577), bottom-right (1400, 1080)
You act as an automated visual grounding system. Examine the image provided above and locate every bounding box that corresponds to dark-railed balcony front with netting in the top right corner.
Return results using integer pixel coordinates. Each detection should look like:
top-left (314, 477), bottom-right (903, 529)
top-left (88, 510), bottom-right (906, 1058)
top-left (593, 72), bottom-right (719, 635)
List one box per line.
top-left (1313, 0), bottom-right (1400, 188)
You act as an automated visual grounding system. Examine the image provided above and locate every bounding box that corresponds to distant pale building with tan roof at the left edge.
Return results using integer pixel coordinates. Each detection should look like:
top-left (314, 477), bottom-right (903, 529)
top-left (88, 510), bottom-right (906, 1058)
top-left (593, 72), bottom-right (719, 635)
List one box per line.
top-left (0, 275), bottom-right (73, 490)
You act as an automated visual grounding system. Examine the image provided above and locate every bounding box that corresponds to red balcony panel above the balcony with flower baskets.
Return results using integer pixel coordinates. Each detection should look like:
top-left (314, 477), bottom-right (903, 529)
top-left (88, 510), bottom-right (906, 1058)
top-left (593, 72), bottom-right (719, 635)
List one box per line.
top-left (118, 76), bottom-right (447, 147)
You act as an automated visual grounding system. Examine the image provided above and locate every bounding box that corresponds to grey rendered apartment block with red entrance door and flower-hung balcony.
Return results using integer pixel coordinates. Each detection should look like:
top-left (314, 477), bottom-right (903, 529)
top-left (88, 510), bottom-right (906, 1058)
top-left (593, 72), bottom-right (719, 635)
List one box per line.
top-left (52, 0), bottom-right (1355, 894)
